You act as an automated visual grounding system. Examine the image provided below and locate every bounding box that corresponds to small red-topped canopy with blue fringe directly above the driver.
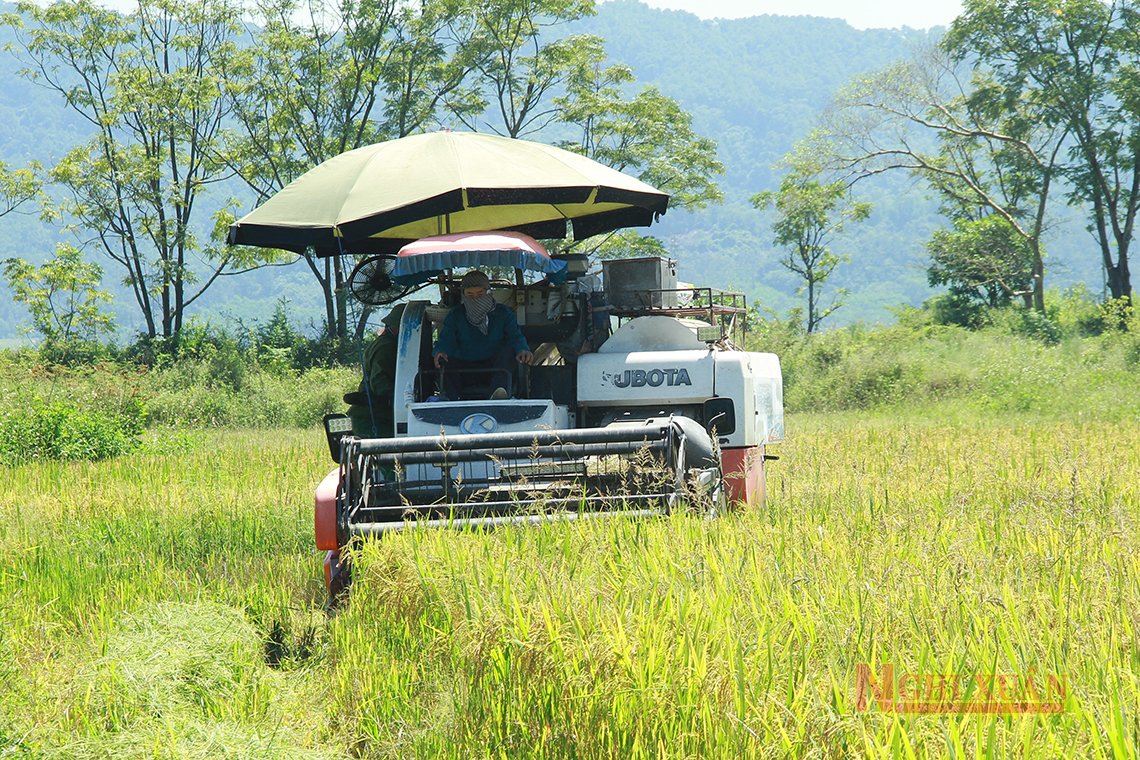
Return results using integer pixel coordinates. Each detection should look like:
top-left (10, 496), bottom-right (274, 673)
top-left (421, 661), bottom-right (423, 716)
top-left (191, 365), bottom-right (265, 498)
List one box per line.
top-left (392, 232), bottom-right (567, 285)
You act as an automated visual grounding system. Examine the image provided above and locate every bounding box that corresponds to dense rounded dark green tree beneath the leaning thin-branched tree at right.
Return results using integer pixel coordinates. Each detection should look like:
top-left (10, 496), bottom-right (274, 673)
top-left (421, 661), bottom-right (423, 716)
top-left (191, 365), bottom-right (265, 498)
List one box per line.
top-left (927, 214), bottom-right (1034, 309)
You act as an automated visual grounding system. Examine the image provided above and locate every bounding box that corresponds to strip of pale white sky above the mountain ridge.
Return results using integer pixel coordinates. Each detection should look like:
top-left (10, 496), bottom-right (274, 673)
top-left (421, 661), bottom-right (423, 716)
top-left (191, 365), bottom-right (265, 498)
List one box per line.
top-left (597, 0), bottom-right (962, 28)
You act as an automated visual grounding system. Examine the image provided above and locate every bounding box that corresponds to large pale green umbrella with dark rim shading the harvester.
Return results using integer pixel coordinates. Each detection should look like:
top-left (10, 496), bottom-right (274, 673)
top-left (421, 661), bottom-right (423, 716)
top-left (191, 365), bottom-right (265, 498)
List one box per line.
top-left (229, 132), bottom-right (669, 254)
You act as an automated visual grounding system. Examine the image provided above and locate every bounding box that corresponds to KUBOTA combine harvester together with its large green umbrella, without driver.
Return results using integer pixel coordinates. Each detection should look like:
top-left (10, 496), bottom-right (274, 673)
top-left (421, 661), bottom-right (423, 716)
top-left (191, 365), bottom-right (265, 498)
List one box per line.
top-left (228, 131), bottom-right (783, 596)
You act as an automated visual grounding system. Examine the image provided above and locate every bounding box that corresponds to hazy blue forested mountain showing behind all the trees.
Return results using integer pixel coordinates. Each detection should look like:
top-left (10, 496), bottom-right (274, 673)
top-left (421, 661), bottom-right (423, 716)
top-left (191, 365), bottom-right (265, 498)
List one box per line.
top-left (0, 0), bottom-right (1100, 340)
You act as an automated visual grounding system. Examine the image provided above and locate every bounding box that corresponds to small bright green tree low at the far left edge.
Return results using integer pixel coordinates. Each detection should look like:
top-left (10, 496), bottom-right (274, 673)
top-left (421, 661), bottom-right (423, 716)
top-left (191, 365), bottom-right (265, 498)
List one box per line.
top-left (3, 245), bottom-right (115, 346)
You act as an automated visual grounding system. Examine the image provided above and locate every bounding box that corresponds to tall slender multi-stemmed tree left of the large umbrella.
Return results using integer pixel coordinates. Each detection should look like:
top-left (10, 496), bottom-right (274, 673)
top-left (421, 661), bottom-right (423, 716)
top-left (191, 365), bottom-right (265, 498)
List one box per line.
top-left (3, 0), bottom-right (278, 341)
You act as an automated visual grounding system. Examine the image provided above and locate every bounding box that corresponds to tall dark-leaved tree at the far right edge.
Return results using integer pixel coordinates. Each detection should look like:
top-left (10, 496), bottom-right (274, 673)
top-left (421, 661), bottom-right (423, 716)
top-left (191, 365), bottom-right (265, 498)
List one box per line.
top-left (943, 0), bottom-right (1140, 309)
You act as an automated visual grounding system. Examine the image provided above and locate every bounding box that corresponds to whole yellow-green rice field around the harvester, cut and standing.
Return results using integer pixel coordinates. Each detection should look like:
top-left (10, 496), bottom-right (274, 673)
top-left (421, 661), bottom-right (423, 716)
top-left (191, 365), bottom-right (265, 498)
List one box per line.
top-left (0, 410), bottom-right (1140, 758)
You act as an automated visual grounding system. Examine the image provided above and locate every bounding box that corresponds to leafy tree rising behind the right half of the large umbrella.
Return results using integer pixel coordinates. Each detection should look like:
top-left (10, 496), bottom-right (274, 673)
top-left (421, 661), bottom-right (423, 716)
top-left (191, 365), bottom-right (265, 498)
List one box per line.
top-left (453, 19), bottom-right (724, 258)
